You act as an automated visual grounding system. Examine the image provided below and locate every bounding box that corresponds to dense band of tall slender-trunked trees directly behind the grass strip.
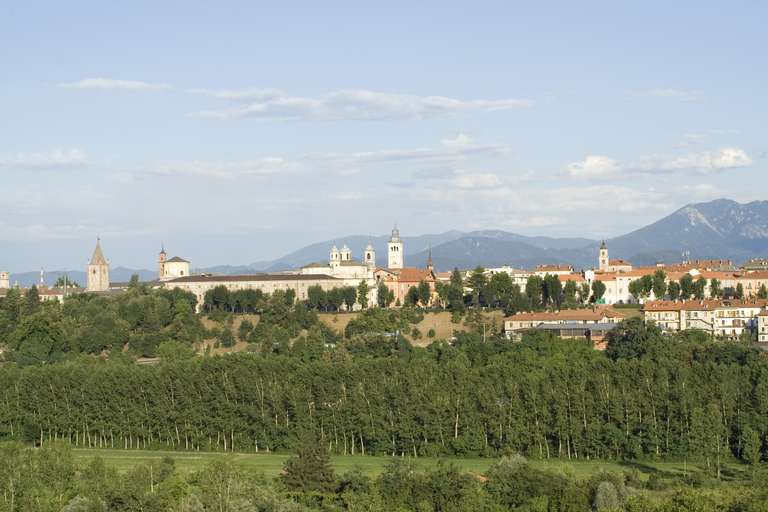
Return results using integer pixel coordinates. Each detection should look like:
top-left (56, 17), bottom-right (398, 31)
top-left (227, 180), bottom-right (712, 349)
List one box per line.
top-left (0, 320), bottom-right (768, 470)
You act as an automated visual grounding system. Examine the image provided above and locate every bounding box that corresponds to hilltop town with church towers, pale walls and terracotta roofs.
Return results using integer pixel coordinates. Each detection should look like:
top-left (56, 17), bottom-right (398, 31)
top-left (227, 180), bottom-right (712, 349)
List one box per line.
top-left (0, 227), bottom-right (768, 348)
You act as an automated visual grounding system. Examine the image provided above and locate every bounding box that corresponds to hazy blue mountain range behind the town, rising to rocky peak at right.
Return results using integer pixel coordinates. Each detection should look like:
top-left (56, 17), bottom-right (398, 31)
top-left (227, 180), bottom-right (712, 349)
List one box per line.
top-left (12, 199), bottom-right (768, 286)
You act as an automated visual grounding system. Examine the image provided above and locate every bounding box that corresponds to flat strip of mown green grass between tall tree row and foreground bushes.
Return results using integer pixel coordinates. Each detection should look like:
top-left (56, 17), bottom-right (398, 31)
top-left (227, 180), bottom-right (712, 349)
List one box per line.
top-left (74, 449), bottom-right (744, 479)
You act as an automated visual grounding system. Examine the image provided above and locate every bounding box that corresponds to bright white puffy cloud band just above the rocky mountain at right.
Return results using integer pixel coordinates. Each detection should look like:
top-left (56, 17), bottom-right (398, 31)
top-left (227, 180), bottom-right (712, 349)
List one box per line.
top-left (566, 147), bottom-right (752, 179)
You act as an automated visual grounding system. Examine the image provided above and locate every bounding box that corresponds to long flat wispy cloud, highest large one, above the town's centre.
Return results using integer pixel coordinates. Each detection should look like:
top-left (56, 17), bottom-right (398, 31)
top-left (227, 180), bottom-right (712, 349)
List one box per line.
top-left (192, 89), bottom-right (532, 121)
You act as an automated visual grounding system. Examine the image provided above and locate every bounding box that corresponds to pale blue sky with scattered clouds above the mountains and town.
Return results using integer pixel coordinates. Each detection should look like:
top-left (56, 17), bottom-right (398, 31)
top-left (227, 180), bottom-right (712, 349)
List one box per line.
top-left (0, 0), bottom-right (768, 272)
